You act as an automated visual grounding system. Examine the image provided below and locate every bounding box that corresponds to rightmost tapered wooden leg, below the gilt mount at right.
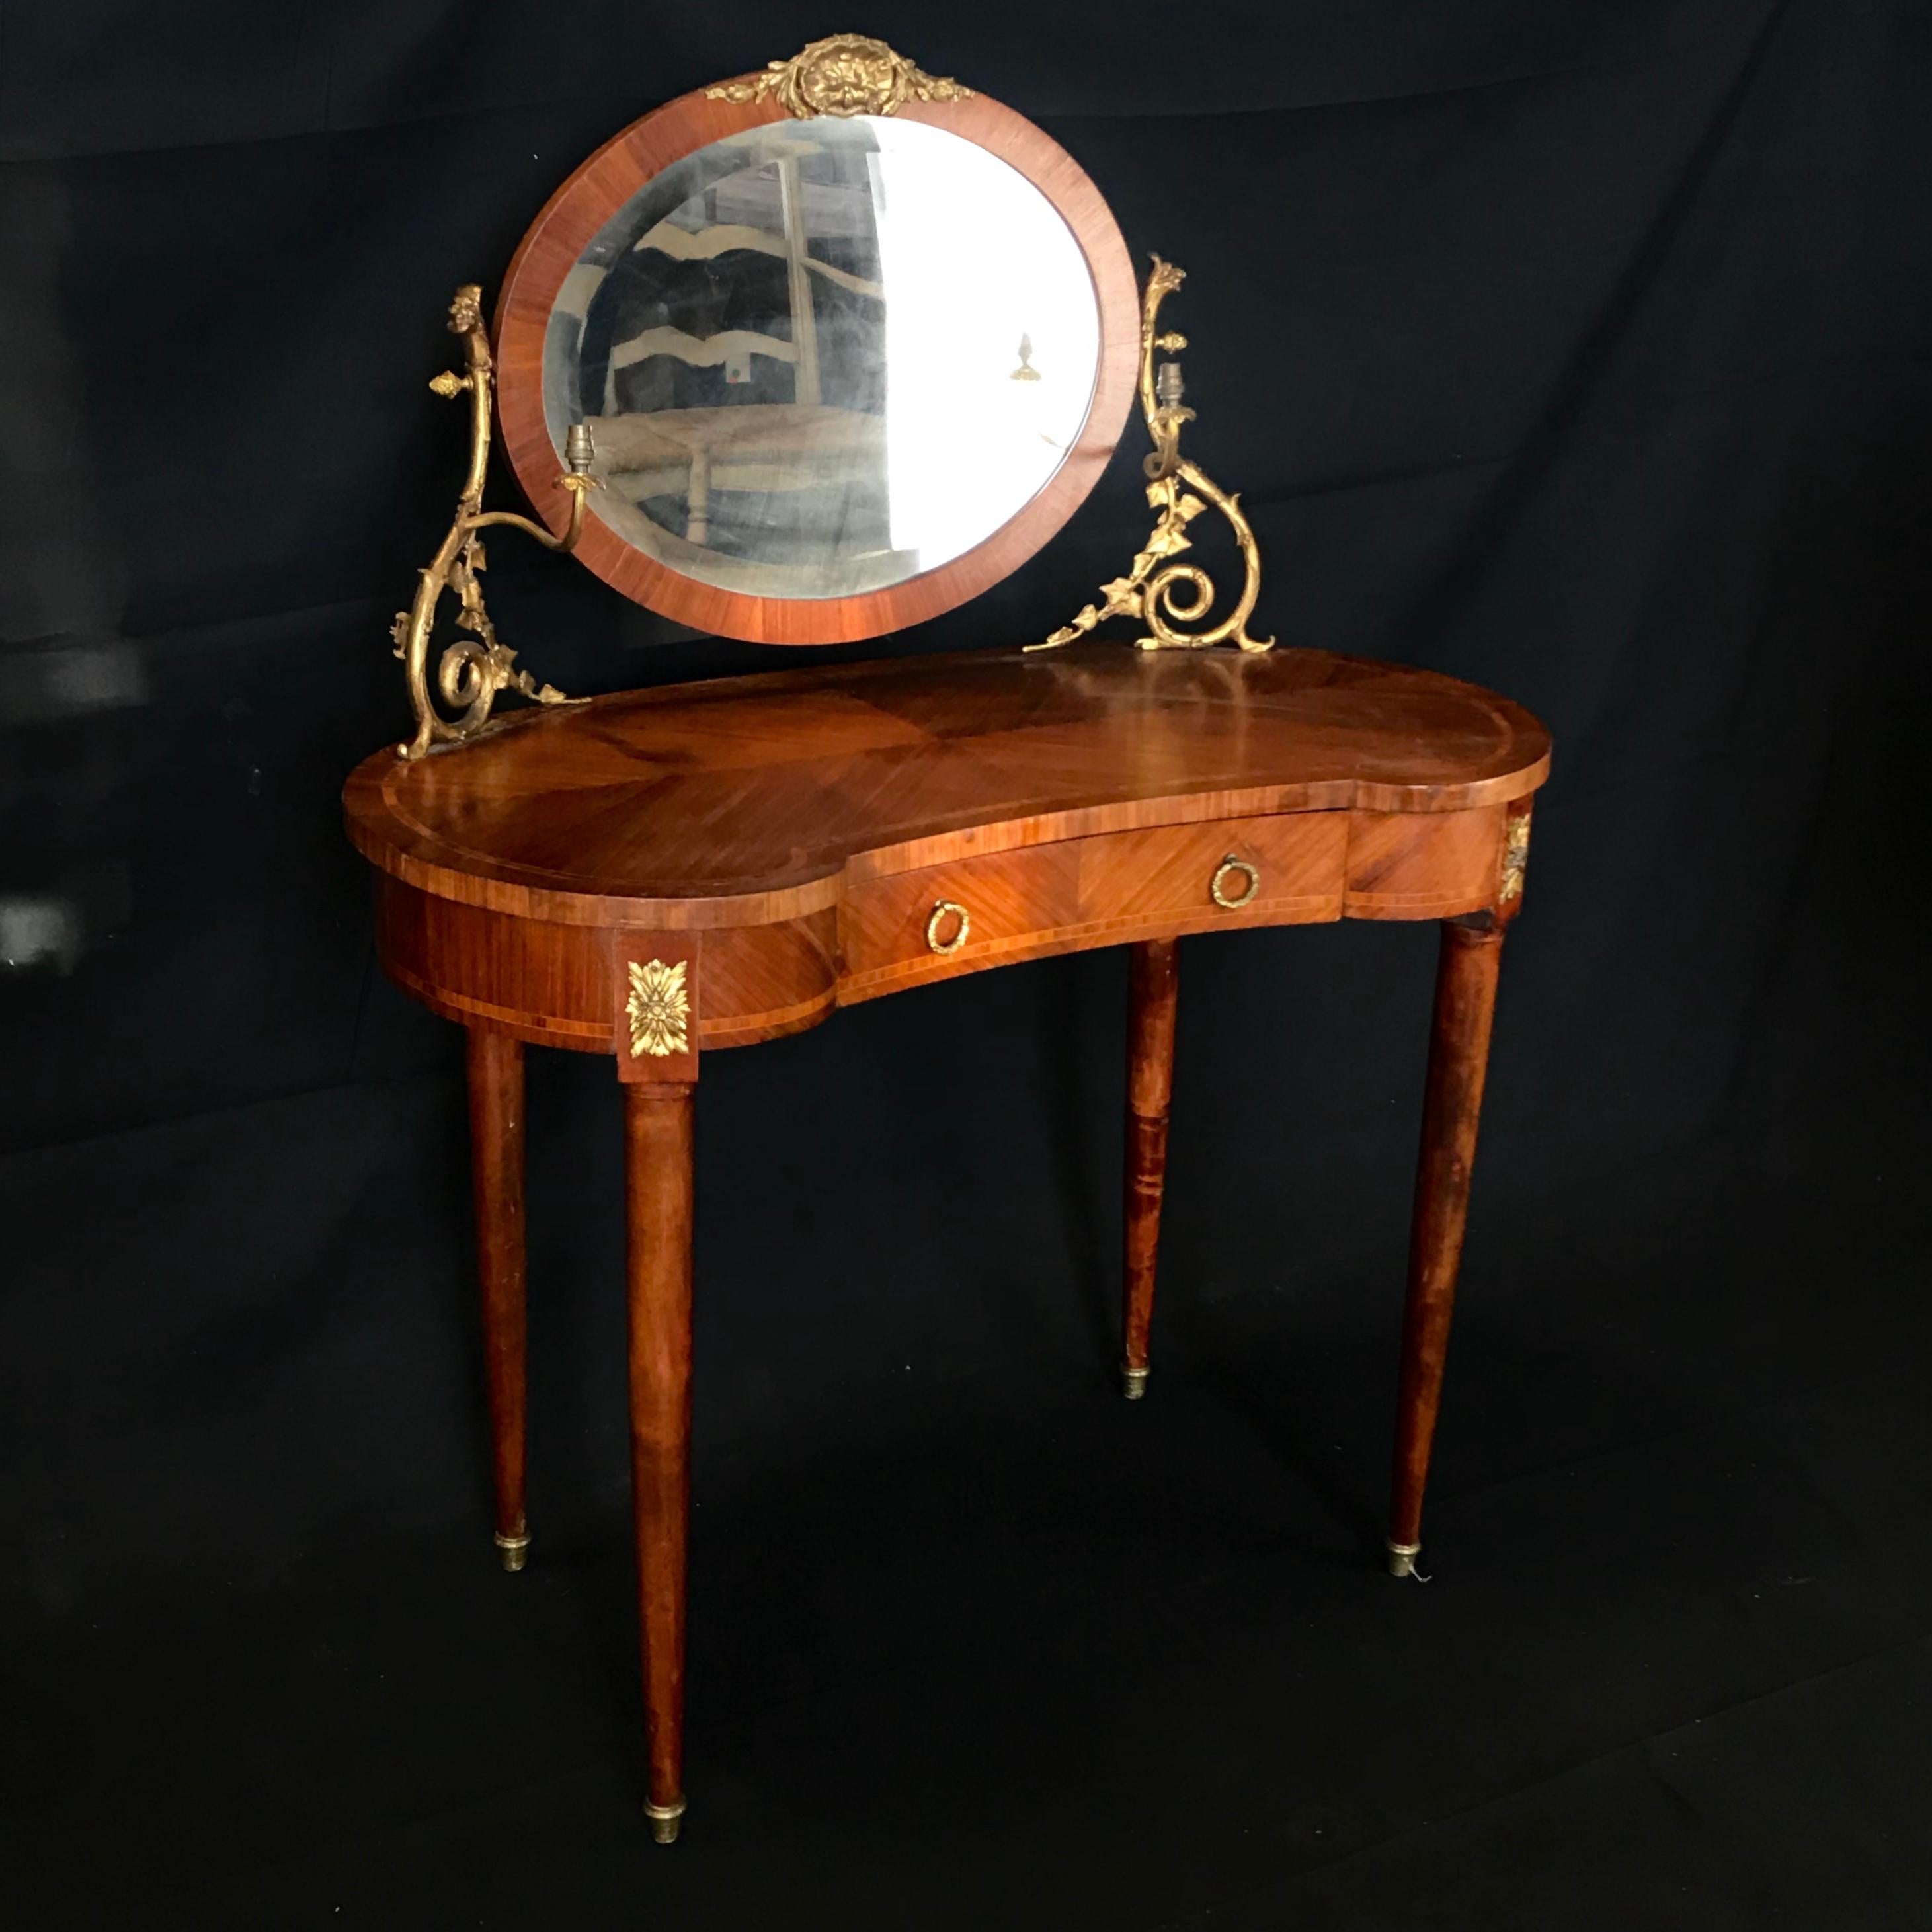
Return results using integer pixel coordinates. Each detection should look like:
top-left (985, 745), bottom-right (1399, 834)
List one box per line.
top-left (1389, 920), bottom-right (1503, 1576)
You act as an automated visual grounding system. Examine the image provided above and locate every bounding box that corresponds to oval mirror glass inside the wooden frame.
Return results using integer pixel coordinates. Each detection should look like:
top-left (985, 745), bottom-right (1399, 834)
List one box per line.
top-left (543, 116), bottom-right (1100, 597)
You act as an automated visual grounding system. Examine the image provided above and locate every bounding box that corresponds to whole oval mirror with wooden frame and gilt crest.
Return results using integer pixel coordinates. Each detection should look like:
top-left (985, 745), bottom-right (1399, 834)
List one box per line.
top-left (497, 37), bottom-right (1140, 643)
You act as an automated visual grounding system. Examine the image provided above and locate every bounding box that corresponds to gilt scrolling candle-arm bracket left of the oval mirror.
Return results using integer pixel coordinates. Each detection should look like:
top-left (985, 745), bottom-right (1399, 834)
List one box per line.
top-left (390, 282), bottom-right (597, 757)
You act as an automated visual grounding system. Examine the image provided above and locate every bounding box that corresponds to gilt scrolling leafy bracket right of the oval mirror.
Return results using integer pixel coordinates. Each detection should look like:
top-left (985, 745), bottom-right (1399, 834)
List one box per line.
top-left (1026, 255), bottom-right (1275, 651)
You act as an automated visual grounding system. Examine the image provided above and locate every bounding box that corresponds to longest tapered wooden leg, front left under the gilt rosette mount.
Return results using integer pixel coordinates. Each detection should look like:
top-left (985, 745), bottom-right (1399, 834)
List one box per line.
top-left (624, 1084), bottom-right (692, 1845)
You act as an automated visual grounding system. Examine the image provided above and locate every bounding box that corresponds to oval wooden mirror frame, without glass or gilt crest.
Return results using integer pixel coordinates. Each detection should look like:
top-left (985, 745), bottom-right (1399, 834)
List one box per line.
top-left (495, 75), bottom-right (1140, 643)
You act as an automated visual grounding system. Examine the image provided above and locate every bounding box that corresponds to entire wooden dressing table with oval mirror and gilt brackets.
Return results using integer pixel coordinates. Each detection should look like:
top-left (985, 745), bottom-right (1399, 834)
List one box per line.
top-left (346, 35), bottom-right (1549, 1843)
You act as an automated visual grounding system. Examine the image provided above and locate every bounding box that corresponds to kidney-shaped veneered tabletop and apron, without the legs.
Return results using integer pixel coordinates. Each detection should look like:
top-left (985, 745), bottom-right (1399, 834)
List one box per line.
top-left (346, 645), bottom-right (1548, 1051)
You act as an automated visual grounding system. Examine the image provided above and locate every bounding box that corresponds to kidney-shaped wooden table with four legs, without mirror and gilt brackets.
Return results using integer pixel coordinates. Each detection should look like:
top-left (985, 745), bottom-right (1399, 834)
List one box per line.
top-left (344, 645), bottom-right (1549, 1839)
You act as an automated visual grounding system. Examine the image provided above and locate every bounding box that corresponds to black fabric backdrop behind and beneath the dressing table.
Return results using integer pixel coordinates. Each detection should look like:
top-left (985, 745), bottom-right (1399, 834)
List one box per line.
top-left (0, 0), bottom-right (1932, 1928)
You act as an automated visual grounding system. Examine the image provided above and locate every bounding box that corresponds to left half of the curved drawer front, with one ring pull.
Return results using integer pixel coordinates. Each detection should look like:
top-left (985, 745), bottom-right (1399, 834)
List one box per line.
top-left (838, 840), bottom-right (1080, 999)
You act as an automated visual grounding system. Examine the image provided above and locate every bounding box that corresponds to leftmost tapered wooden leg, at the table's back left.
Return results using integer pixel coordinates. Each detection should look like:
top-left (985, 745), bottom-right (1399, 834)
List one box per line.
top-left (467, 1026), bottom-right (530, 1571)
